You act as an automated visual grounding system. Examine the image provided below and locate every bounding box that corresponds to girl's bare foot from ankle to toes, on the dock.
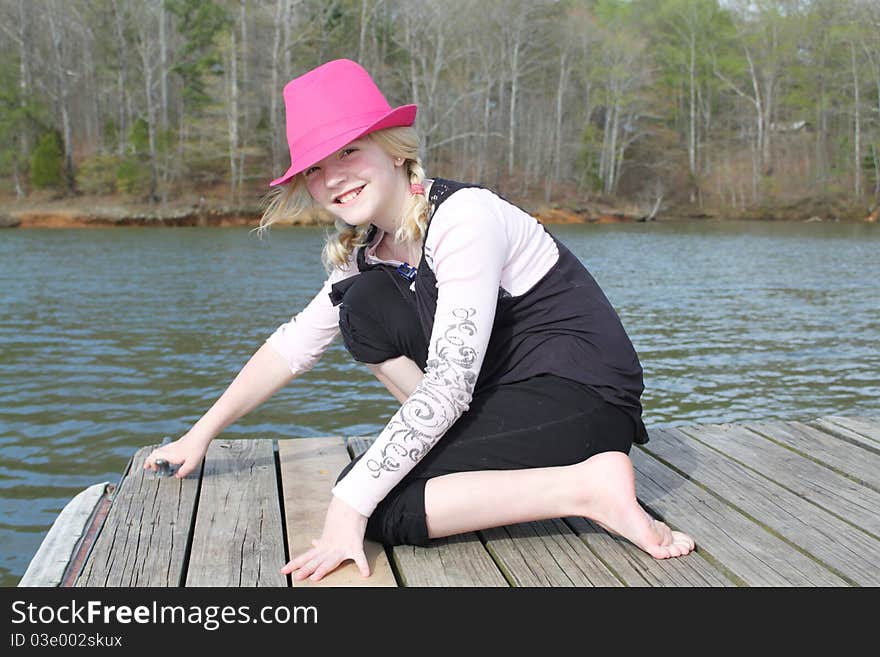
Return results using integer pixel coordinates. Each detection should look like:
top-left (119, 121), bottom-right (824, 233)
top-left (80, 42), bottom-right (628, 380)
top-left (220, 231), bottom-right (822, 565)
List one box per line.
top-left (572, 452), bottom-right (694, 559)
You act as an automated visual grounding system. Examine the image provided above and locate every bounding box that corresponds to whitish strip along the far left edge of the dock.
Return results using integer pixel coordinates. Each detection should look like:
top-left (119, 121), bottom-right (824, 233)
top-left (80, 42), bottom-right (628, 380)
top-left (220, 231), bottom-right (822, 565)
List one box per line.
top-left (18, 481), bottom-right (112, 586)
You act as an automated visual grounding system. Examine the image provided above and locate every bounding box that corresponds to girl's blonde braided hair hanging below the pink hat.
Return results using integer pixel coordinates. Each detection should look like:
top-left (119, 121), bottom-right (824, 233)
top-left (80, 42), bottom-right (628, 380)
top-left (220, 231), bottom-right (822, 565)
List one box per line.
top-left (257, 127), bottom-right (430, 272)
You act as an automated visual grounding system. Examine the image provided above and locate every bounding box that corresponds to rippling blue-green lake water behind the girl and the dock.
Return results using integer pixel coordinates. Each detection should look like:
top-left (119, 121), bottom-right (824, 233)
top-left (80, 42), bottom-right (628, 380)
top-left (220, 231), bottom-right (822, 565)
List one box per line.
top-left (0, 222), bottom-right (880, 586)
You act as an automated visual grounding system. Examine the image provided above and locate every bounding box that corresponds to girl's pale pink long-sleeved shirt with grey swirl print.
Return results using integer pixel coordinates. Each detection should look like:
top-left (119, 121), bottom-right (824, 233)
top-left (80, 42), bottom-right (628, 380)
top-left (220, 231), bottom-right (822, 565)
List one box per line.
top-left (267, 182), bottom-right (559, 516)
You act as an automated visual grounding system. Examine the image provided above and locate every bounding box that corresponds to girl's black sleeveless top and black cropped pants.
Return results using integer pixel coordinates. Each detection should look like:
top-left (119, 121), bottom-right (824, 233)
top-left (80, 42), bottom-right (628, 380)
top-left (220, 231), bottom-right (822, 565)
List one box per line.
top-left (330, 179), bottom-right (648, 545)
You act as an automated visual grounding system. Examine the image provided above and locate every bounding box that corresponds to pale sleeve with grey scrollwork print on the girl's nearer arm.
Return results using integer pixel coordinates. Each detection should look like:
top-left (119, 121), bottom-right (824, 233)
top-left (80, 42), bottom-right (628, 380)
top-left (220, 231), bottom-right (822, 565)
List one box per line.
top-left (333, 190), bottom-right (507, 516)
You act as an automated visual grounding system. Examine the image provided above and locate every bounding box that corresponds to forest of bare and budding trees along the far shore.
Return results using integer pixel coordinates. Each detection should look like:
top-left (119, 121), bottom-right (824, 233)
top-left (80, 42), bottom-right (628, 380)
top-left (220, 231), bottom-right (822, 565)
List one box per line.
top-left (0, 0), bottom-right (880, 219)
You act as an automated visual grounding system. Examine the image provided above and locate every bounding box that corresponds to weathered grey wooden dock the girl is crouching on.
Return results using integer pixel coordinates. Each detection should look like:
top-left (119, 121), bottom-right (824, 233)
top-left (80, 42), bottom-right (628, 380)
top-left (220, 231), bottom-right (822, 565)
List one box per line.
top-left (19, 416), bottom-right (880, 587)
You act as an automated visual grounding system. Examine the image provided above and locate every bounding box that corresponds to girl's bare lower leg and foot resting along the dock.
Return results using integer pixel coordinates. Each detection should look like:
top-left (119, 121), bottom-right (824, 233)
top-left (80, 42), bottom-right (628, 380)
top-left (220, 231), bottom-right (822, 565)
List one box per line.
top-left (425, 452), bottom-right (694, 559)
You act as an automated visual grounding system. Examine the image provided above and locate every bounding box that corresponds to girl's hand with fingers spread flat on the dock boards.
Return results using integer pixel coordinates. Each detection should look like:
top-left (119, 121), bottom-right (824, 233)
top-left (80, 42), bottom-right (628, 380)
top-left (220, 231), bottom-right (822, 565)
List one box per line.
top-left (281, 495), bottom-right (370, 582)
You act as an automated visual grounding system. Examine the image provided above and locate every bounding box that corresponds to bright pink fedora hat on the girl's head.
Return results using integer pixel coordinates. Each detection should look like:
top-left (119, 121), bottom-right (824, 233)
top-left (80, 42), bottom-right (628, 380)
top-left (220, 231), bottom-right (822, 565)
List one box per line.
top-left (269, 59), bottom-right (417, 187)
